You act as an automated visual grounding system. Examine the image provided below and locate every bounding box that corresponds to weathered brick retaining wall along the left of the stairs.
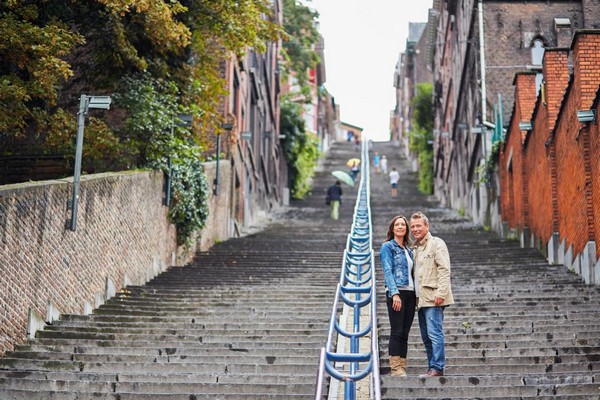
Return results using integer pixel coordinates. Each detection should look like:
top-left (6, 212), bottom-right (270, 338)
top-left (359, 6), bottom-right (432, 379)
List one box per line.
top-left (0, 162), bottom-right (231, 354)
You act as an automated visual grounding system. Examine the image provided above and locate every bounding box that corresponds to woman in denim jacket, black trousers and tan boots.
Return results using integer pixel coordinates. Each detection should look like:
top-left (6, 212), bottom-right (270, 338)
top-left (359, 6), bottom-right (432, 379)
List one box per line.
top-left (379, 215), bottom-right (416, 376)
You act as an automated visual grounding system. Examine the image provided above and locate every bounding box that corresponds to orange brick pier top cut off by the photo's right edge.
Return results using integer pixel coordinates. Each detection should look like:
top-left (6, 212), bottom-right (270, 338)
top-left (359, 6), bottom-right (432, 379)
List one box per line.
top-left (571, 29), bottom-right (600, 110)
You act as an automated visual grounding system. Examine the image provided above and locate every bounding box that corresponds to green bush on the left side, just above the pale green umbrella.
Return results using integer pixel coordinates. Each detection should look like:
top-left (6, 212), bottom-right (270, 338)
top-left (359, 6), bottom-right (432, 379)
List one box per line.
top-left (281, 99), bottom-right (319, 199)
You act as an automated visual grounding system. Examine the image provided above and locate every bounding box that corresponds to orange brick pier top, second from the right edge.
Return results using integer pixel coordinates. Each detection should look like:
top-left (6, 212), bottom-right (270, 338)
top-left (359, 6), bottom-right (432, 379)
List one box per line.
top-left (542, 48), bottom-right (569, 132)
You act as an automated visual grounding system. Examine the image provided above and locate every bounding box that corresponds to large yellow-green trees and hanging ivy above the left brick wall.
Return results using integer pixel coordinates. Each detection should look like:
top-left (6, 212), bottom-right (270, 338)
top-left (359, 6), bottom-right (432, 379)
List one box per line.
top-left (0, 0), bottom-right (285, 244)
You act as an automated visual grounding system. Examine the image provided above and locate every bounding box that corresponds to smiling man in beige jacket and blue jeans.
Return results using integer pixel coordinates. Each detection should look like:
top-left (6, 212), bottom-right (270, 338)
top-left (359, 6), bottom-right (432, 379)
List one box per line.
top-left (410, 212), bottom-right (454, 377)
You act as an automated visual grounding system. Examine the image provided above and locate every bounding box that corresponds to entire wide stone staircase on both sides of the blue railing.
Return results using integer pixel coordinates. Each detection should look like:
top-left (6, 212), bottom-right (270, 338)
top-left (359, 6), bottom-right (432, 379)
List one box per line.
top-left (0, 142), bottom-right (600, 400)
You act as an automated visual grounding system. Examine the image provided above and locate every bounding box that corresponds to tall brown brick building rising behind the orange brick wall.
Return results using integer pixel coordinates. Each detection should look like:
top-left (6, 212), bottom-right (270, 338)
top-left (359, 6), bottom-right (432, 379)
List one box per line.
top-left (429, 0), bottom-right (600, 230)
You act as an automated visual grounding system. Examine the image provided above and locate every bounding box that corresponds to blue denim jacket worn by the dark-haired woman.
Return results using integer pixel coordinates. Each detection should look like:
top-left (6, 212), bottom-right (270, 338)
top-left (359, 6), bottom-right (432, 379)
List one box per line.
top-left (379, 239), bottom-right (414, 297)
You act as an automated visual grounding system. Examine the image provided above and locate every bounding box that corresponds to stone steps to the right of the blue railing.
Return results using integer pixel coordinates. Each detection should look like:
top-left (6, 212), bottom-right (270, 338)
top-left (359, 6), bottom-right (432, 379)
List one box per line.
top-left (371, 144), bottom-right (600, 400)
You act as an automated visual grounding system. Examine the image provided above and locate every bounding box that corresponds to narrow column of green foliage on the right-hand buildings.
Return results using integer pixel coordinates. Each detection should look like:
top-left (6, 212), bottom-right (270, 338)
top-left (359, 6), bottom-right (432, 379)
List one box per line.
top-left (409, 82), bottom-right (433, 194)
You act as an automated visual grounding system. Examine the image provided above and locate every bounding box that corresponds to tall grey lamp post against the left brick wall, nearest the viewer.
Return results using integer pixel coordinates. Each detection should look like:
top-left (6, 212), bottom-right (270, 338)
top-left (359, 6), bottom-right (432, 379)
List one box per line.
top-left (67, 94), bottom-right (111, 231)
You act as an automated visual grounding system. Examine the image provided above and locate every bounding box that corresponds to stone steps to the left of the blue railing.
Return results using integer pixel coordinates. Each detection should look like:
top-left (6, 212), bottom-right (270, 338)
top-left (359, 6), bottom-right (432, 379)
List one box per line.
top-left (0, 143), bottom-right (356, 400)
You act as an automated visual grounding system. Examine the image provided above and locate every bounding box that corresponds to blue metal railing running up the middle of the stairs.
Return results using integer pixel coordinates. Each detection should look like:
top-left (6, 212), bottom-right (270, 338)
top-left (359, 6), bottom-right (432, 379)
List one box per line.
top-left (315, 137), bottom-right (381, 400)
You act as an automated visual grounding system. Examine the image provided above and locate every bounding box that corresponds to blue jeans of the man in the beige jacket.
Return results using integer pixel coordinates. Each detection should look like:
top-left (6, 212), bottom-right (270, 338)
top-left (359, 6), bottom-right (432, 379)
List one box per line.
top-left (419, 307), bottom-right (446, 372)
